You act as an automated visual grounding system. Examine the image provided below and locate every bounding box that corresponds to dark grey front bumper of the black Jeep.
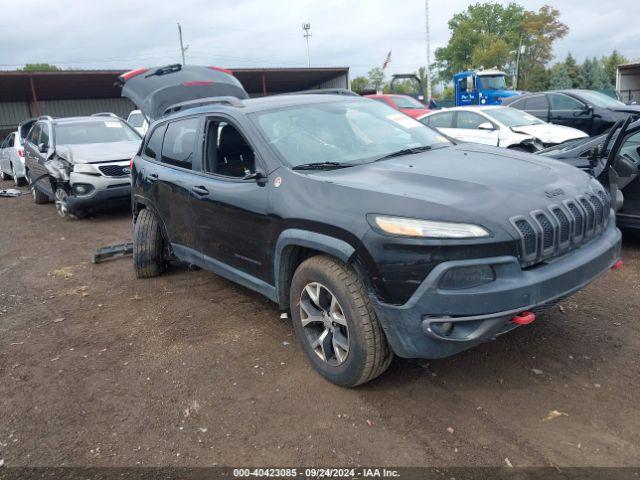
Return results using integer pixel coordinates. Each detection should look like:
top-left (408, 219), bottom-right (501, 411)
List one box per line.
top-left (371, 221), bottom-right (621, 358)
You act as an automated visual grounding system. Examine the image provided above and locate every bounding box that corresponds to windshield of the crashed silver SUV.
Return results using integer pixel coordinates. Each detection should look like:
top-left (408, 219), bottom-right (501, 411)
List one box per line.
top-left (55, 119), bottom-right (140, 145)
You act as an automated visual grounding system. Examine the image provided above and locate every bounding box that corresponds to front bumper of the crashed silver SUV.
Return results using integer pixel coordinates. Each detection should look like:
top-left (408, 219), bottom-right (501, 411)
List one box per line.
top-left (67, 172), bottom-right (131, 210)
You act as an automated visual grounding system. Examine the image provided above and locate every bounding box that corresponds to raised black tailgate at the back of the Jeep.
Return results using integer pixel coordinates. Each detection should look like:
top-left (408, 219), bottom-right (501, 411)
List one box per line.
top-left (118, 64), bottom-right (249, 120)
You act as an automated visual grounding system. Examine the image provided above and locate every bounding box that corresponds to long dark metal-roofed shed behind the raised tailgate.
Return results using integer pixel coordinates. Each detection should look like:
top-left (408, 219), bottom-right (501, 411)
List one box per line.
top-left (0, 67), bottom-right (349, 134)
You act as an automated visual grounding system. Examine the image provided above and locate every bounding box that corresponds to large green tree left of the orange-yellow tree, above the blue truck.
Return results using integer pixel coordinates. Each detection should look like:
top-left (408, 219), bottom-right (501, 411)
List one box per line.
top-left (435, 2), bottom-right (524, 81)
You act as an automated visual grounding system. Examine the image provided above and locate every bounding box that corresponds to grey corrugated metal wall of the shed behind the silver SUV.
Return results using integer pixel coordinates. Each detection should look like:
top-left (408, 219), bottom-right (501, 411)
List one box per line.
top-left (0, 98), bottom-right (135, 132)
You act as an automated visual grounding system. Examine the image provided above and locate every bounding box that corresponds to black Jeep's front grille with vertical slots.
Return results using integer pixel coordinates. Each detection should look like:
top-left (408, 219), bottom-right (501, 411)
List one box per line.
top-left (511, 191), bottom-right (611, 267)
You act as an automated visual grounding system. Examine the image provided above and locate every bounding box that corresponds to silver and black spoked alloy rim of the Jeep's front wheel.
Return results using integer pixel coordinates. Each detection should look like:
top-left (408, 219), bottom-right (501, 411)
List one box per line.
top-left (300, 282), bottom-right (349, 366)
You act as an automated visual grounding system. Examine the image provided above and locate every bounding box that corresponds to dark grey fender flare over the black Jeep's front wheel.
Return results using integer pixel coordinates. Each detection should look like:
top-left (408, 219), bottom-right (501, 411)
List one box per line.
top-left (273, 228), bottom-right (356, 306)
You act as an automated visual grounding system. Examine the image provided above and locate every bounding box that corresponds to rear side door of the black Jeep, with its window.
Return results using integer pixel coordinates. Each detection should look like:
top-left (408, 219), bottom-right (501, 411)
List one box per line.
top-left (140, 116), bottom-right (200, 251)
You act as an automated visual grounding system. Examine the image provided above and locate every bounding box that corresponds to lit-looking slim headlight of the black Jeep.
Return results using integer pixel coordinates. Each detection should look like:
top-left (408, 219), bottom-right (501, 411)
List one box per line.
top-left (372, 215), bottom-right (489, 238)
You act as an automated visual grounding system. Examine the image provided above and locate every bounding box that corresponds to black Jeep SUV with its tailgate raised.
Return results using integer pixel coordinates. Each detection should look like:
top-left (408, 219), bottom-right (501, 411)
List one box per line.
top-left (122, 66), bottom-right (620, 386)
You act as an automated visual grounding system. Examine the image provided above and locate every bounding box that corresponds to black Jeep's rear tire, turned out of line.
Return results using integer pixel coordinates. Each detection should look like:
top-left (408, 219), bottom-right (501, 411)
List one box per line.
top-left (133, 208), bottom-right (167, 278)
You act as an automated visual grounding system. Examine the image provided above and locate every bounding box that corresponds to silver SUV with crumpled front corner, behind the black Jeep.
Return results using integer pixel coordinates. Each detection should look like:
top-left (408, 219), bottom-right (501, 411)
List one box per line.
top-left (24, 113), bottom-right (142, 218)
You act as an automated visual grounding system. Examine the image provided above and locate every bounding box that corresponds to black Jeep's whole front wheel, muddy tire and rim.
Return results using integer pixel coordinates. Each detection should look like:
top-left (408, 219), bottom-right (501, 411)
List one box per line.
top-left (289, 255), bottom-right (393, 387)
